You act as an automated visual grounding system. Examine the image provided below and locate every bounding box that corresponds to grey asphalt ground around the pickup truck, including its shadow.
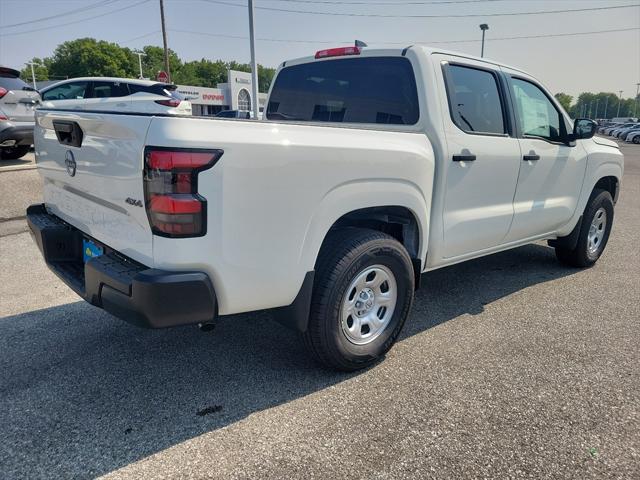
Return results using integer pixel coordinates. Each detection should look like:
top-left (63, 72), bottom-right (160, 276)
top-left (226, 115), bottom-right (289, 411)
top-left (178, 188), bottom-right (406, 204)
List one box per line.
top-left (0, 141), bottom-right (640, 479)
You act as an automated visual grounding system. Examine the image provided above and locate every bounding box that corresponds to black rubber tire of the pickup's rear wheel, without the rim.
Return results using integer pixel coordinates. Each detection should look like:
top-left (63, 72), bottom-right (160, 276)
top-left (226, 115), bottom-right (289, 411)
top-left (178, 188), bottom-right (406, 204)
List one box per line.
top-left (303, 228), bottom-right (415, 371)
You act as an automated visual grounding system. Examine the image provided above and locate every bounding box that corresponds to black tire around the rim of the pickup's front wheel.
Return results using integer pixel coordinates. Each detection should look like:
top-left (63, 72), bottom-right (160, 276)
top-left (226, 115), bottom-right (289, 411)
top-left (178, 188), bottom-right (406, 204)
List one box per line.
top-left (556, 189), bottom-right (613, 268)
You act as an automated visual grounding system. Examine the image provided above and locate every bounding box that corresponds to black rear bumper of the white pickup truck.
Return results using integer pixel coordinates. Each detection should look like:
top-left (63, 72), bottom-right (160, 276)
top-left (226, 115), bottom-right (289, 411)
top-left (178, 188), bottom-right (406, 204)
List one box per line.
top-left (27, 205), bottom-right (217, 328)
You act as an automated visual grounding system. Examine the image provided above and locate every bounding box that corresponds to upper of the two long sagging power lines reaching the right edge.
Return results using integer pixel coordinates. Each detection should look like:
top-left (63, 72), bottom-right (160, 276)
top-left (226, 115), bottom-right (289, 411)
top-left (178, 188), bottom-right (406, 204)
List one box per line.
top-left (200, 0), bottom-right (640, 18)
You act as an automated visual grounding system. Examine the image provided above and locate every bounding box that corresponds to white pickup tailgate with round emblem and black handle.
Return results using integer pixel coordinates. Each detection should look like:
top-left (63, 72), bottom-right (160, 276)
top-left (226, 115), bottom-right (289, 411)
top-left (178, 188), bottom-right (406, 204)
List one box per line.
top-left (34, 110), bottom-right (153, 266)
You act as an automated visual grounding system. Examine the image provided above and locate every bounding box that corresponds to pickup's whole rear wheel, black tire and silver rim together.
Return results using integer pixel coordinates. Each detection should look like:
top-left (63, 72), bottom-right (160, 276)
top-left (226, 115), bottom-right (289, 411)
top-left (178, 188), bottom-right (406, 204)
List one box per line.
top-left (303, 228), bottom-right (414, 371)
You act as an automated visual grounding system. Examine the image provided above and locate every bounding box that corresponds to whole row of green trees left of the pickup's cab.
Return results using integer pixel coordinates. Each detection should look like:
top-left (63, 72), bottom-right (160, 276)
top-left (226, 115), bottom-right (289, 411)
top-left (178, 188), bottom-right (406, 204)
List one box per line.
top-left (21, 38), bottom-right (275, 92)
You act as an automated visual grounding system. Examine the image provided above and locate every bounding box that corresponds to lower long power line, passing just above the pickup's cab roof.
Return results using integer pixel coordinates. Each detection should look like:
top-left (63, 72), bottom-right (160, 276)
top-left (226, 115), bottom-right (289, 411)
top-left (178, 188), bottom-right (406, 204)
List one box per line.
top-left (169, 27), bottom-right (640, 45)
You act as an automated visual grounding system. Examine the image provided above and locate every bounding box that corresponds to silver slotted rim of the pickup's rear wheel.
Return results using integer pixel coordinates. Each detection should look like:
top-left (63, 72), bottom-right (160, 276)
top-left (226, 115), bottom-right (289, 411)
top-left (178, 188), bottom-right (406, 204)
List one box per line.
top-left (340, 265), bottom-right (398, 345)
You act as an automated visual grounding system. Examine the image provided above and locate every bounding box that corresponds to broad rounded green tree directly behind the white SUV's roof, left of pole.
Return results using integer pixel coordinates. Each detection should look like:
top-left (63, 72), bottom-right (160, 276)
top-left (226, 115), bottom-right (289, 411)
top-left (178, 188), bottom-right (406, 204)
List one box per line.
top-left (49, 38), bottom-right (137, 77)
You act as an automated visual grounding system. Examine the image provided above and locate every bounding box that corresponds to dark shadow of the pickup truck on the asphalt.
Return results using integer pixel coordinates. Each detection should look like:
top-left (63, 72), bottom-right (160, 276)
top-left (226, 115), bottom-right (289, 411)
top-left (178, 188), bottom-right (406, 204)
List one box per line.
top-left (0, 245), bottom-right (575, 478)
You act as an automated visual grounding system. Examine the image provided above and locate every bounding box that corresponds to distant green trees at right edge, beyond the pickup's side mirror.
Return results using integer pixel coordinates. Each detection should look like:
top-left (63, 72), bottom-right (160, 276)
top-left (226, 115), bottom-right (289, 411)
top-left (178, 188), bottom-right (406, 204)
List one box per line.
top-left (555, 92), bottom-right (640, 118)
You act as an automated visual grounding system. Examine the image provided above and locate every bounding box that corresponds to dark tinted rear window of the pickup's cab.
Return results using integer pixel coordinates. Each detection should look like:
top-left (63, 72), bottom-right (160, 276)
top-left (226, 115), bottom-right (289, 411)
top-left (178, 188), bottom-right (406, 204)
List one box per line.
top-left (267, 57), bottom-right (419, 125)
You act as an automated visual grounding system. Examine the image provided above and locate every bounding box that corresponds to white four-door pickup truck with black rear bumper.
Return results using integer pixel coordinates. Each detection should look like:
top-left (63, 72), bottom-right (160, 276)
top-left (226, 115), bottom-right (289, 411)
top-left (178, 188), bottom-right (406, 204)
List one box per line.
top-left (27, 46), bottom-right (623, 370)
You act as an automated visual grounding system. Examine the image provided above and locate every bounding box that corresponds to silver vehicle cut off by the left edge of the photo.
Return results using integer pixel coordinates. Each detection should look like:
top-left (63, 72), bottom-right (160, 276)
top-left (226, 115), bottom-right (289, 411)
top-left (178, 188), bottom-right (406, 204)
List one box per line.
top-left (0, 66), bottom-right (40, 160)
